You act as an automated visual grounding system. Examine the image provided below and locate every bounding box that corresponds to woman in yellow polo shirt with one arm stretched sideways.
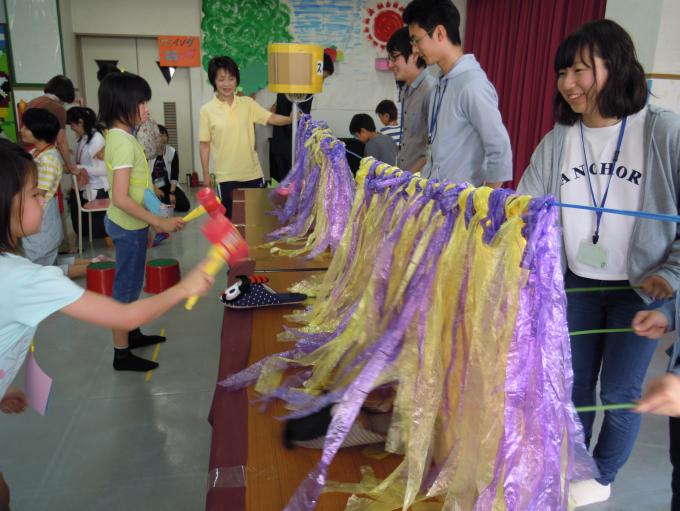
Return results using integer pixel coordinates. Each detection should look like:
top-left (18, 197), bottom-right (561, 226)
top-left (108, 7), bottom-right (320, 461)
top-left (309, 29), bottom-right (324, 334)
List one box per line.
top-left (198, 57), bottom-right (291, 218)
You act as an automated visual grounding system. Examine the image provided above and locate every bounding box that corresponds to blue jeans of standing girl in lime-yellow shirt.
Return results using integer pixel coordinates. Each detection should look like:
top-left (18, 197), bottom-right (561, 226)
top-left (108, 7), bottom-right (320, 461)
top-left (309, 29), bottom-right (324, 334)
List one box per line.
top-left (104, 216), bottom-right (149, 303)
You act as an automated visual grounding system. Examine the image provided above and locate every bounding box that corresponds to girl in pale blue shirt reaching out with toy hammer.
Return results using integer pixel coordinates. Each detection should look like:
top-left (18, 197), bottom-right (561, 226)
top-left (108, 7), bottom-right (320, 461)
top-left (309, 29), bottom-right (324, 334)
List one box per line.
top-left (0, 140), bottom-right (214, 509)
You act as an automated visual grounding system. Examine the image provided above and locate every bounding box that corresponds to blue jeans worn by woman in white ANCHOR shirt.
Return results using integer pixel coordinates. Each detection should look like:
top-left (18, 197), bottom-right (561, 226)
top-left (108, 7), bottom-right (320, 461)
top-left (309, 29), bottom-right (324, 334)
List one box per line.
top-left (565, 271), bottom-right (662, 484)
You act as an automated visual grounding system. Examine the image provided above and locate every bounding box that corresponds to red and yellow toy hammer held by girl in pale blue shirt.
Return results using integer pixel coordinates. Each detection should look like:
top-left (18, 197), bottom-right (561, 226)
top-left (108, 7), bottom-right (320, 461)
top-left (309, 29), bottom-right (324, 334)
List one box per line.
top-left (184, 215), bottom-right (248, 310)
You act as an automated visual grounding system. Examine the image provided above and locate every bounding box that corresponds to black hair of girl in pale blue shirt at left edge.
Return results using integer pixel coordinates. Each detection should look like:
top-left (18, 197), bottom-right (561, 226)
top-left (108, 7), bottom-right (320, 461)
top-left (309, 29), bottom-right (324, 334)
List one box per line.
top-left (0, 139), bottom-right (38, 254)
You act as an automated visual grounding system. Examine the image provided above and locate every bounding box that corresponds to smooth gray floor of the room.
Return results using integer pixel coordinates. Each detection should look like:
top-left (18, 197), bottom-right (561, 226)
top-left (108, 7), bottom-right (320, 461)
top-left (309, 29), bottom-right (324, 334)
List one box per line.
top-left (0, 197), bottom-right (670, 511)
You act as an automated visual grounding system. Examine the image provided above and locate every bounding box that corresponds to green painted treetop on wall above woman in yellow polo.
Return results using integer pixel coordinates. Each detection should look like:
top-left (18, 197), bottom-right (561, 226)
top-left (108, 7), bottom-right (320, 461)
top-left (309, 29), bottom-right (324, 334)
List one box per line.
top-left (201, 0), bottom-right (293, 94)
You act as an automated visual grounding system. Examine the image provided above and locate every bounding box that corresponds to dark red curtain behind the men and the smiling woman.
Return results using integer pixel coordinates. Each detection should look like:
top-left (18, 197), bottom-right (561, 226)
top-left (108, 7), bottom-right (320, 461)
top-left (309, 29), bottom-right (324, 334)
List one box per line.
top-left (463, 0), bottom-right (607, 188)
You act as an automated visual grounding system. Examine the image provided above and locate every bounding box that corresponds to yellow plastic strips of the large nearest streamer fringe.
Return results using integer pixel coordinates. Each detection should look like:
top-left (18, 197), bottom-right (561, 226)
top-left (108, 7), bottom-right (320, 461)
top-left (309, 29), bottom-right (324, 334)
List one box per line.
top-left (257, 158), bottom-right (530, 511)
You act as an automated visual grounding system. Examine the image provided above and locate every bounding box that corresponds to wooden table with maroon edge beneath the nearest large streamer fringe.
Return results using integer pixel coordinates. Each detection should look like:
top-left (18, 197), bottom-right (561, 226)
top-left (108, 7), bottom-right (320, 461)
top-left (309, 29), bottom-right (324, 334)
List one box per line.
top-left (206, 271), bottom-right (400, 511)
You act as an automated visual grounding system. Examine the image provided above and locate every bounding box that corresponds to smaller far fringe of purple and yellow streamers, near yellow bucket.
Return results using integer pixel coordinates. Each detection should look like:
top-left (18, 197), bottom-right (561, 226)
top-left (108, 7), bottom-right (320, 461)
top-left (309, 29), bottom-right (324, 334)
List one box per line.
top-left (265, 114), bottom-right (355, 259)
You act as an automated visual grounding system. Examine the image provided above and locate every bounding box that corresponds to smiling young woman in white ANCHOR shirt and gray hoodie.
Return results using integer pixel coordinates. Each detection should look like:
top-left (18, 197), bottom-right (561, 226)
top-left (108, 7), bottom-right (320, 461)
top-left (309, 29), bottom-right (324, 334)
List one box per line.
top-left (518, 20), bottom-right (680, 506)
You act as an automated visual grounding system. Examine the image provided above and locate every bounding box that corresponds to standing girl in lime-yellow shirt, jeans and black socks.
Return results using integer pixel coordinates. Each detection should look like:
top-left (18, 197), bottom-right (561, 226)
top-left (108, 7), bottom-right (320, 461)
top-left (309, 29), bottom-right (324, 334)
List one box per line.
top-left (99, 73), bottom-right (184, 371)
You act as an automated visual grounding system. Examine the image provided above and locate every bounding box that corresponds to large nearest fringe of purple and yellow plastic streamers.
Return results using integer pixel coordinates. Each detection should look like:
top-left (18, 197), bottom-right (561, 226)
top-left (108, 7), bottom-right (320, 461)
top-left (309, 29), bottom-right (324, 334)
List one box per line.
top-left (220, 158), bottom-right (597, 511)
